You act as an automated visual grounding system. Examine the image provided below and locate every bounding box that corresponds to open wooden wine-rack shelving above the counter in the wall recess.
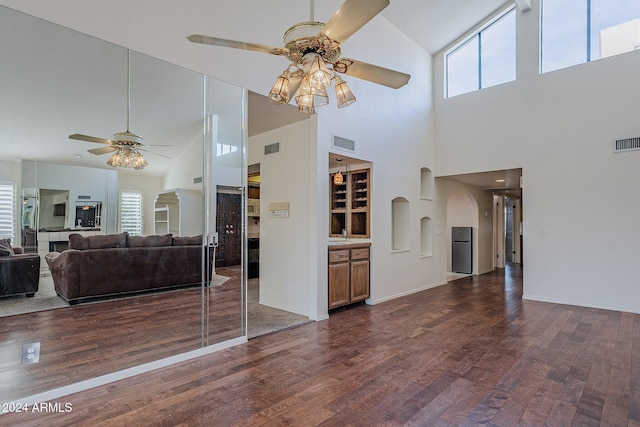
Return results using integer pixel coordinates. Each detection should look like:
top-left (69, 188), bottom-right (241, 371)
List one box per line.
top-left (329, 169), bottom-right (371, 238)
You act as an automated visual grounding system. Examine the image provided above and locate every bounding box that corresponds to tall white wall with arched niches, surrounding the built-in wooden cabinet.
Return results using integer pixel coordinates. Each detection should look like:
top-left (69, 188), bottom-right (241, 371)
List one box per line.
top-left (316, 19), bottom-right (438, 313)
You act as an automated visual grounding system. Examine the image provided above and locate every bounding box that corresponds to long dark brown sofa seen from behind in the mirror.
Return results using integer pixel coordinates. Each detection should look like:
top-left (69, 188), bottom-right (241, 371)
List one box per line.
top-left (46, 232), bottom-right (202, 304)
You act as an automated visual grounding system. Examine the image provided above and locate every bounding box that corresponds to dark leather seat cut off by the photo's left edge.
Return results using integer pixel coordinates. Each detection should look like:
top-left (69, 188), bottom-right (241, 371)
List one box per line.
top-left (0, 239), bottom-right (40, 297)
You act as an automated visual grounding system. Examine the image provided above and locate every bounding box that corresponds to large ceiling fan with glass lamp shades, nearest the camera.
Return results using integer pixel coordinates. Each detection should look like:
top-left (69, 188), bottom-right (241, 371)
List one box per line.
top-left (187, 0), bottom-right (411, 113)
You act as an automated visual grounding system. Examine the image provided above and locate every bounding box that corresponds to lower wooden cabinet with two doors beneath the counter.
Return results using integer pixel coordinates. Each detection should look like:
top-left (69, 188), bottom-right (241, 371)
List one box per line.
top-left (329, 243), bottom-right (371, 309)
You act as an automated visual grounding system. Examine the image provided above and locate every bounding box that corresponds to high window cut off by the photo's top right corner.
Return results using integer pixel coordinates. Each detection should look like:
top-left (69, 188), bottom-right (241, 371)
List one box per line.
top-left (540, 0), bottom-right (640, 73)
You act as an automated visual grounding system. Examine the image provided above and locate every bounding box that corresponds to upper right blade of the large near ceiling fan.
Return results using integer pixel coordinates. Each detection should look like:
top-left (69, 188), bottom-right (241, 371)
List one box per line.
top-left (320, 0), bottom-right (389, 43)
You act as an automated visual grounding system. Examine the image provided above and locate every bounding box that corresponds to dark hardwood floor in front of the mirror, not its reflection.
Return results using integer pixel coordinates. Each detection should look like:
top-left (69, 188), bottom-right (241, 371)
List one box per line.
top-left (0, 266), bottom-right (640, 426)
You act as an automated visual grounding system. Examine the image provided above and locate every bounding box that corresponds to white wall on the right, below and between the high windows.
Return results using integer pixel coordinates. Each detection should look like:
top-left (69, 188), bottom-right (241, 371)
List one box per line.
top-left (434, 0), bottom-right (640, 312)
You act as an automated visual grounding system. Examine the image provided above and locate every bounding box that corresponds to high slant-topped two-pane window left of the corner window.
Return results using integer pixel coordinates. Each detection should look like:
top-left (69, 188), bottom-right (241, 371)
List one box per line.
top-left (445, 6), bottom-right (516, 98)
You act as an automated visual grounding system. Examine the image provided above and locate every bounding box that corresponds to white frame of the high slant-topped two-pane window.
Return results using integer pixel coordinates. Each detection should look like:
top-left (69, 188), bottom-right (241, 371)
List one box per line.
top-left (444, 2), bottom-right (518, 99)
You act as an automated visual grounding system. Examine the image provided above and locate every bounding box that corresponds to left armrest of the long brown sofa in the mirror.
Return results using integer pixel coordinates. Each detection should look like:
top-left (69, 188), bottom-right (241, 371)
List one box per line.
top-left (45, 249), bottom-right (80, 301)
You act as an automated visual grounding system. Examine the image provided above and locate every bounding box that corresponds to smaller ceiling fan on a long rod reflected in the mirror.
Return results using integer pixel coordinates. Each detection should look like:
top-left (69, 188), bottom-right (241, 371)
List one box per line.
top-left (69, 50), bottom-right (169, 170)
